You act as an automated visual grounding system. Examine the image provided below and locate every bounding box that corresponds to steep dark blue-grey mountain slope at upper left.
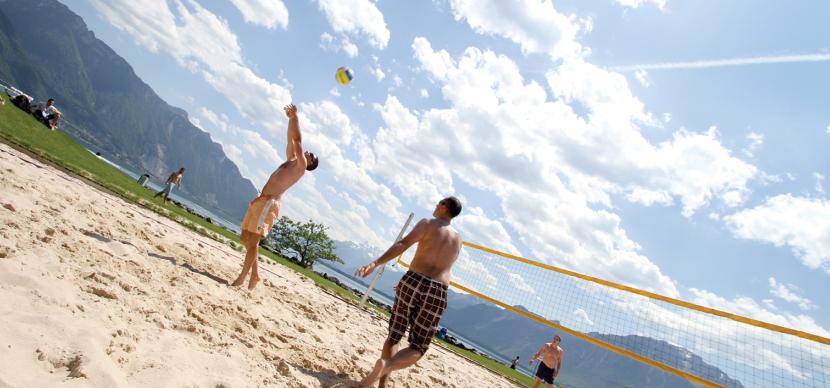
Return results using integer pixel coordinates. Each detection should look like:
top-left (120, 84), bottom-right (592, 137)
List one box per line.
top-left (0, 0), bottom-right (257, 221)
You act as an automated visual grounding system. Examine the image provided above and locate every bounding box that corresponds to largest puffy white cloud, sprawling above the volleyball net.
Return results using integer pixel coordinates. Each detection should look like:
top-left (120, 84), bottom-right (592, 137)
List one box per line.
top-left (398, 38), bottom-right (757, 295)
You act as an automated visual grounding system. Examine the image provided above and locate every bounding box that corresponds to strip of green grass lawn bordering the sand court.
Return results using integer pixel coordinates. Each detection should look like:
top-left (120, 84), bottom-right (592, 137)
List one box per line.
top-left (0, 101), bottom-right (533, 386)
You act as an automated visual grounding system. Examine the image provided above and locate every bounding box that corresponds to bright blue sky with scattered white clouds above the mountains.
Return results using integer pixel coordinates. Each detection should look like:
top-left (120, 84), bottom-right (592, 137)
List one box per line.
top-left (64, 0), bottom-right (830, 356)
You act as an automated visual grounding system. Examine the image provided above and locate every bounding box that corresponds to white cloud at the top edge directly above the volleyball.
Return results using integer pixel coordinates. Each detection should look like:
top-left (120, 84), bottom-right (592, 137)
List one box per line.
top-left (318, 0), bottom-right (390, 49)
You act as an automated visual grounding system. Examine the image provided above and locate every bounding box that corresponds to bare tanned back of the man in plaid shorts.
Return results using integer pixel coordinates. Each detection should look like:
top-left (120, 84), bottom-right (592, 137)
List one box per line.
top-left (409, 218), bottom-right (461, 284)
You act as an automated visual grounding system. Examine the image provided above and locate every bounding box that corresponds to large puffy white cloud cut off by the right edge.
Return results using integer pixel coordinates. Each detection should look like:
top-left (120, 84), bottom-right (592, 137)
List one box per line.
top-left (724, 194), bottom-right (830, 274)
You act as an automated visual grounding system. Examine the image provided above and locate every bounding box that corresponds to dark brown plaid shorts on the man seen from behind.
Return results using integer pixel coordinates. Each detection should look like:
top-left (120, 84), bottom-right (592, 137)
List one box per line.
top-left (389, 271), bottom-right (447, 354)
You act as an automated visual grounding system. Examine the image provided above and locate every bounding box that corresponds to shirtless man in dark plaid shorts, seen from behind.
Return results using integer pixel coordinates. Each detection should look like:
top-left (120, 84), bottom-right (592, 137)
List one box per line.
top-left (355, 197), bottom-right (461, 387)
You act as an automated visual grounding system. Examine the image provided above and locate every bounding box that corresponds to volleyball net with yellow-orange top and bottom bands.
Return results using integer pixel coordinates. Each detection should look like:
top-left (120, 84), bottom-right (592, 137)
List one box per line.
top-left (398, 242), bottom-right (830, 387)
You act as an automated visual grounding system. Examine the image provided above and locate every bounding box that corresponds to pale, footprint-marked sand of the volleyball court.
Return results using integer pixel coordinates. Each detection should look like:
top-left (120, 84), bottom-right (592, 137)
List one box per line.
top-left (0, 143), bottom-right (514, 388)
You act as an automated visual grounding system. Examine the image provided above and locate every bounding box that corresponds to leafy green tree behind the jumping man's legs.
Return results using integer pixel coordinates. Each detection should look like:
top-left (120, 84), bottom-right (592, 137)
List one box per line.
top-left (263, 216), bottom-right (343, 268)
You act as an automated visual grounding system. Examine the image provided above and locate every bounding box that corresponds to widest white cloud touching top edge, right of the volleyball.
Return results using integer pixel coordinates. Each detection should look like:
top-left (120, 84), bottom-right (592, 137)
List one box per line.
top-left (450, 0), bottom-right (582, 58)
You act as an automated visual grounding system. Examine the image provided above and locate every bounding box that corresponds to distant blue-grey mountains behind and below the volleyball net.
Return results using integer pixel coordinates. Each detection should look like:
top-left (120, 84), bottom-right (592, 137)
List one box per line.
top-left (327, 241), bottom-right (743, 388)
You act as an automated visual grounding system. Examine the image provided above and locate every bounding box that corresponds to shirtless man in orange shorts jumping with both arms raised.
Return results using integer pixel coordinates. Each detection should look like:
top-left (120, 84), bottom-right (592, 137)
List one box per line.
top-left (231, 104), bottom-right (319, 290)
